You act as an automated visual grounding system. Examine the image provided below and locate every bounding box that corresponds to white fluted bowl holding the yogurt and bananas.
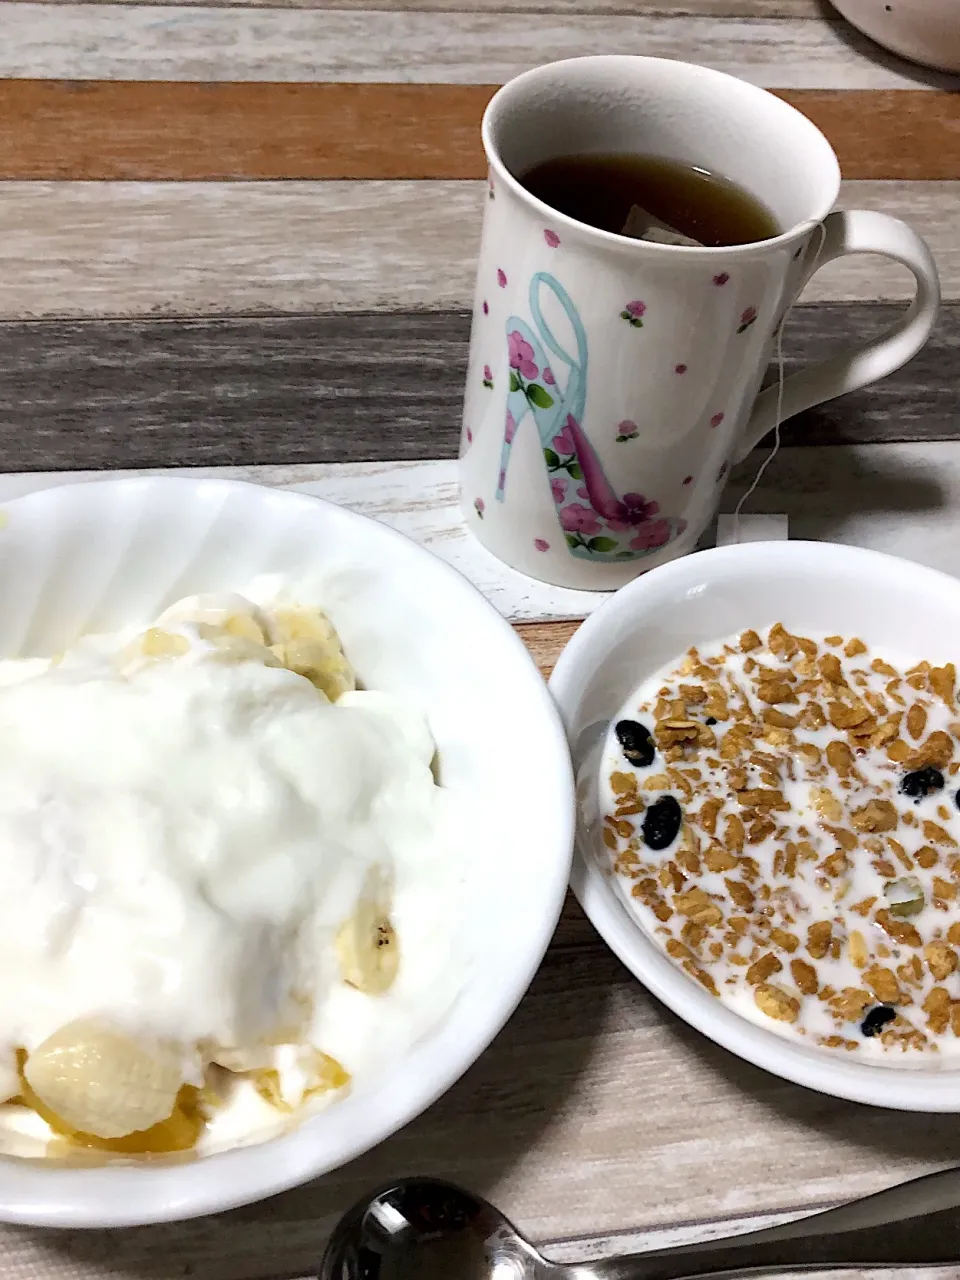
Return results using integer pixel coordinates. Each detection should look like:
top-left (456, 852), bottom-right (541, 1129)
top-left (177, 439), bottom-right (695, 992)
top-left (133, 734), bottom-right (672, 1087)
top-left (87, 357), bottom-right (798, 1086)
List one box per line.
top-left (0, 479), bottom-right (573, 1228)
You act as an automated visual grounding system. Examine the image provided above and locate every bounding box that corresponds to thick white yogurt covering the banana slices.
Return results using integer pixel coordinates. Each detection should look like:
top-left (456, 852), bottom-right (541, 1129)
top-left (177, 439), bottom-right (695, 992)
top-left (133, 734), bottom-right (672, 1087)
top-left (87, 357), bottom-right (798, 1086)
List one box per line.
top-left (0, 588), bottom-right (463, 1142)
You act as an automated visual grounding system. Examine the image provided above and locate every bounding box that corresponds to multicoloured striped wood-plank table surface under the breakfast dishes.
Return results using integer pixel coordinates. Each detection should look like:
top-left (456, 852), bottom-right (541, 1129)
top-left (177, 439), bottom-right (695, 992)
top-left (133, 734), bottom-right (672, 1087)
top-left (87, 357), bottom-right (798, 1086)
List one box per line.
top-left (0, 0), bottom-right (960, 1280)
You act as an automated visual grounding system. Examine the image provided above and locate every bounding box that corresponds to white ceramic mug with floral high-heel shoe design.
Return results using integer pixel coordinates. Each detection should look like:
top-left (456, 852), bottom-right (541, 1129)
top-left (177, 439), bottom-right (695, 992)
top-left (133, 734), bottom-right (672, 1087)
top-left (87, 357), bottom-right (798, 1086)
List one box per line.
top-left (460, 56), bottom-right (940, 590)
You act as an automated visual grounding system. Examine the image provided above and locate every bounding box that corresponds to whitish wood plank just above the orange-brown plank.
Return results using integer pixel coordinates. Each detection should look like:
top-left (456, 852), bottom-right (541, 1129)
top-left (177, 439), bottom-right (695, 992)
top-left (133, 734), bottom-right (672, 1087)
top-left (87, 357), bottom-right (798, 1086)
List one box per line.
top-left (0, 0), bottom-right (960, 90)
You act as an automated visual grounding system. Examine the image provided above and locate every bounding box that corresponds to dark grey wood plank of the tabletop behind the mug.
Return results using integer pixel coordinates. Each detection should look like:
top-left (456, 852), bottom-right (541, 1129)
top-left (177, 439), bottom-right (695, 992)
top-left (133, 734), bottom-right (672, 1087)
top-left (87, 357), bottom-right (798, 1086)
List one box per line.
top-left (0, 303), bottom-right (960, 471)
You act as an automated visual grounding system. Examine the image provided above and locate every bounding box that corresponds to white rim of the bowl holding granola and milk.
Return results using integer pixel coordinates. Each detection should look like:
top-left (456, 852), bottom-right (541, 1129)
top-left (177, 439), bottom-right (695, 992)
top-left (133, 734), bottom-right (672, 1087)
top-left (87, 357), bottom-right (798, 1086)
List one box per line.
top-left (549, 540), bottom-right (960, 1112)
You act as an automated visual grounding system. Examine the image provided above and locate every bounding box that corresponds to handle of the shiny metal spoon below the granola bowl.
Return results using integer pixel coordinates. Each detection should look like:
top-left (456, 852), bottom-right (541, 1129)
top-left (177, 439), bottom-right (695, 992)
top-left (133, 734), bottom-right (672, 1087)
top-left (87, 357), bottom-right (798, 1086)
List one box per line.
top-left (591, 1169), bottom-right (960, 1280)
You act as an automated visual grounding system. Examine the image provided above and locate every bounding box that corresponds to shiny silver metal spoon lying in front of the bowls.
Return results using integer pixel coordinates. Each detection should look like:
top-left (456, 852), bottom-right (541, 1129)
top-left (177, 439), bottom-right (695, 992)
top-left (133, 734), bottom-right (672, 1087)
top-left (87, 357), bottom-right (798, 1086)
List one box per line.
top-left (320, 1169), bottom-right (960, 1280)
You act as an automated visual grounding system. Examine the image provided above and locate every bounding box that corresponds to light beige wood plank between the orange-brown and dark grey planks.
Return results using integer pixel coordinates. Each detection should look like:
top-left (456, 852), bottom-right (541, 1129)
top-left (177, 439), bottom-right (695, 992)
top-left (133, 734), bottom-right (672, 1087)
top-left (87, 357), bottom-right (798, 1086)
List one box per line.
top-left (0, 182), bottom-right (960, 319)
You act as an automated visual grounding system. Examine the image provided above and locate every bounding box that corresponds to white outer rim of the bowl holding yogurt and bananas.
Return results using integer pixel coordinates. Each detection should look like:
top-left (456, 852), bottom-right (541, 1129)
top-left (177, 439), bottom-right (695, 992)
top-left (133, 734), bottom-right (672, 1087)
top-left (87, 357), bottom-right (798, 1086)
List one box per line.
top-left (0, 476), bottom-right (575, 1229)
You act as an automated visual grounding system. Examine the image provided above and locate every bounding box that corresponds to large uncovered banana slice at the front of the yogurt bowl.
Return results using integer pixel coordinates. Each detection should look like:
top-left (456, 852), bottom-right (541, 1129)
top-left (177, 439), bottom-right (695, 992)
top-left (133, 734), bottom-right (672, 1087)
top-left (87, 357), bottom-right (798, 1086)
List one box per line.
top-left (23, 1019), bottom-right (183, 1139)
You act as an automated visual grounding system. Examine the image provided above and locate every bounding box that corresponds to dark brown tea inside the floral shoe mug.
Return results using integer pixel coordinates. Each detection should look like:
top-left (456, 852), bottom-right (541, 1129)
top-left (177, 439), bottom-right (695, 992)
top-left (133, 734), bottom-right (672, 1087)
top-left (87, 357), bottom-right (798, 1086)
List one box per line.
top-left (517, 155), bottom-right (781, 248)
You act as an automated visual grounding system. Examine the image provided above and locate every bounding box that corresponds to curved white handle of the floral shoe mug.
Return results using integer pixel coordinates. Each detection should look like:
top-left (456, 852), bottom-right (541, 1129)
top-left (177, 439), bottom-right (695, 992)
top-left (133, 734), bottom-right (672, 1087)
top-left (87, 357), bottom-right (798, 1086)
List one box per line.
top-left (736, 209), bottom-right (940, 462)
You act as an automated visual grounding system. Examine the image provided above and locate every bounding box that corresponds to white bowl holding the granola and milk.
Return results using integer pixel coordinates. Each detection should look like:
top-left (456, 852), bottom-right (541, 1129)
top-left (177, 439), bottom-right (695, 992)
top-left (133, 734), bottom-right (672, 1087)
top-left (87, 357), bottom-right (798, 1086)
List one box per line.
top-left (550, 541), bottom-right (960, 1111)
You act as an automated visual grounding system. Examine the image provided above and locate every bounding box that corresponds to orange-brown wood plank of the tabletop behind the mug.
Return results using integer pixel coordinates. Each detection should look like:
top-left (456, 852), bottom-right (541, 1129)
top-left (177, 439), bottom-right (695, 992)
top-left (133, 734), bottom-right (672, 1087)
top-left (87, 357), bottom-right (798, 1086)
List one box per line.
top-left (0, 83), bottom-right (960, 180)
